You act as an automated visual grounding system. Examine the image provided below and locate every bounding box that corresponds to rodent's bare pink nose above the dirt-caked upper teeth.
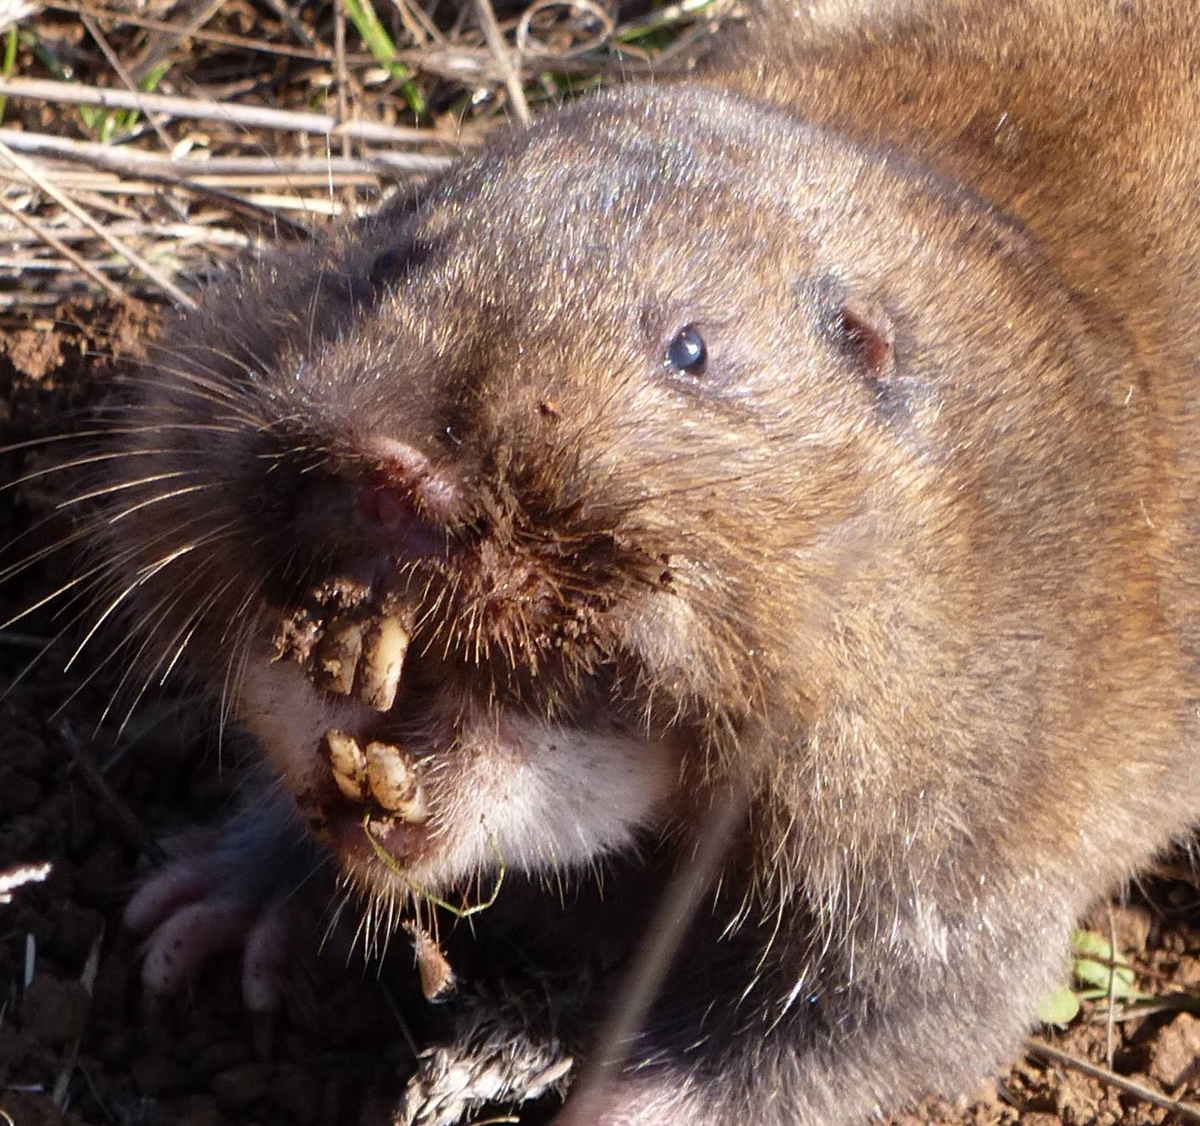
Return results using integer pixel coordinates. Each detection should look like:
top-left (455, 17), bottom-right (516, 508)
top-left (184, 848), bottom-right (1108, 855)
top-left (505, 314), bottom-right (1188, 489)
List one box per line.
top-left (359, 438), bottom-right (461, 557)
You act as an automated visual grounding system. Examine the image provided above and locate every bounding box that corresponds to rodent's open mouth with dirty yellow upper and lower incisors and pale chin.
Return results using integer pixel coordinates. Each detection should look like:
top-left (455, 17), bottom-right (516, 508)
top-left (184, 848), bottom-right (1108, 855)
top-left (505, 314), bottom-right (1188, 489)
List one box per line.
top-left (239, 540), bottom-right (679, 894)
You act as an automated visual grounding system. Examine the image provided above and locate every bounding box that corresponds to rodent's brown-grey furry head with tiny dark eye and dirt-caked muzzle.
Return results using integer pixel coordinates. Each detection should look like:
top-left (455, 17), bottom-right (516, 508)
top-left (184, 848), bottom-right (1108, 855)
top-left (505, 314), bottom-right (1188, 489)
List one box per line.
top-left (93, 89), bottom-right (1099, 880)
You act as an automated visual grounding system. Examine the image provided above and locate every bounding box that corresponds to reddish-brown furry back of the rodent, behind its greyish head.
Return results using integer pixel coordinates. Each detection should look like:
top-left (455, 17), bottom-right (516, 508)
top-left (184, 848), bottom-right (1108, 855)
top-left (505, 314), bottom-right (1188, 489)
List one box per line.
top-left (708, 0), bottom-right (1200, 744)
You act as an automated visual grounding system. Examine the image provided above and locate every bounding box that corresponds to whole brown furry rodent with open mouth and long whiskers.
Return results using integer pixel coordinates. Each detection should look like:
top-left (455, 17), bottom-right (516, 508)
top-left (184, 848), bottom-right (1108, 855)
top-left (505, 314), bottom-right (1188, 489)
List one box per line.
top-left (84, 0), bottom-right (1200, 1126)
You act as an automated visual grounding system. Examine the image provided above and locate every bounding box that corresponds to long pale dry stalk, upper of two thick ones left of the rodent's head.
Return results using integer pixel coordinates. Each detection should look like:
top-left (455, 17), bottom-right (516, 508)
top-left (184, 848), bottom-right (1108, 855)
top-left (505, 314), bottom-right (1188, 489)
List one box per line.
top-left (0, 78), bottom-right (457, 149)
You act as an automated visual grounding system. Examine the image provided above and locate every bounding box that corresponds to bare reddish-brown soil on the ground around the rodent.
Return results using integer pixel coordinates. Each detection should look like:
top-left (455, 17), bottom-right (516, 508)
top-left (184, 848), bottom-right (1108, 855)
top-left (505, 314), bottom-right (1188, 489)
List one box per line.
top-left (0, 5), bottom-right (1200, 1126)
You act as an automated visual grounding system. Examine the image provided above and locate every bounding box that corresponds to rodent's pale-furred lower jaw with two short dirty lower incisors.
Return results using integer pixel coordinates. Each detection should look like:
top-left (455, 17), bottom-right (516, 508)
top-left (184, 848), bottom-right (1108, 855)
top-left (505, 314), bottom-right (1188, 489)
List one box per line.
top-left (239, 614), bottom-right (680, 896)
